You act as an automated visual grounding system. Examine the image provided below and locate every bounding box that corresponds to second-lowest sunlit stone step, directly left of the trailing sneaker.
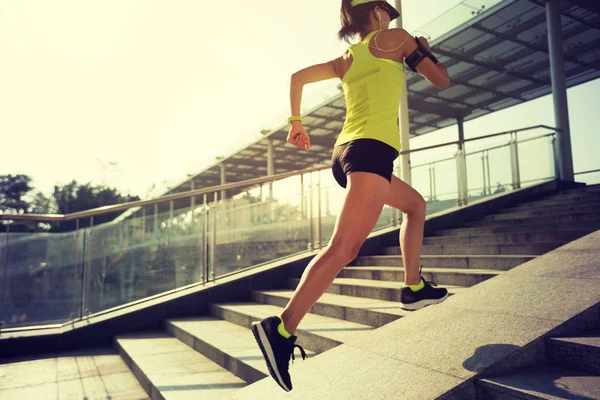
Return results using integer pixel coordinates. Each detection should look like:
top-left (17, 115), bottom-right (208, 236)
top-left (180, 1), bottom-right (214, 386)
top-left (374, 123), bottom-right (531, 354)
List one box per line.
top-left (165, 317), bottom-right (314, 384)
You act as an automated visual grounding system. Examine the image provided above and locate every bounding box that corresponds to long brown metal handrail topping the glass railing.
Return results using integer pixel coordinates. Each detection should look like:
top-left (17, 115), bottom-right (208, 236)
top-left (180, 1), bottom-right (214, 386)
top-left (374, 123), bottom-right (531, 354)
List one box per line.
top-left (0, 125), bottom-right (559, 222)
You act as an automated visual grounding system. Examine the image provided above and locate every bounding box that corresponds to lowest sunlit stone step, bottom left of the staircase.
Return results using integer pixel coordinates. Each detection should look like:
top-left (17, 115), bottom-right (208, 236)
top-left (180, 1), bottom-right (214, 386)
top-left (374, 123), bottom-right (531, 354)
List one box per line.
top-left (115, 332), bottom-right (247, 400)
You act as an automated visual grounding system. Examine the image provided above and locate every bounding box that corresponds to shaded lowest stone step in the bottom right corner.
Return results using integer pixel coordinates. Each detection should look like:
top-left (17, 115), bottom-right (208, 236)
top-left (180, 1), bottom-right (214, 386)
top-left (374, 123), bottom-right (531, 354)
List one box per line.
top-left (476, 366), bottom-right (600, 400)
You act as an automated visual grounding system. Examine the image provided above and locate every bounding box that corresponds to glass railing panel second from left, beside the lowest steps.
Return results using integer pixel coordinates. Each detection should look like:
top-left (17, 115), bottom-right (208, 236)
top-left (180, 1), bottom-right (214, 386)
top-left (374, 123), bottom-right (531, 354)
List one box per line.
top-left (84, 200), bottom-right (206, 315)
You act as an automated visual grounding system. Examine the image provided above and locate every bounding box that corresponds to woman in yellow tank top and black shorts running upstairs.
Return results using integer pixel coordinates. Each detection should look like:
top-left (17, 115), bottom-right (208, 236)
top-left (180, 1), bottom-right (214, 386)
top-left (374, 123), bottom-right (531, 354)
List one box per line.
top-left (252, 0), bottom-right (450, 391)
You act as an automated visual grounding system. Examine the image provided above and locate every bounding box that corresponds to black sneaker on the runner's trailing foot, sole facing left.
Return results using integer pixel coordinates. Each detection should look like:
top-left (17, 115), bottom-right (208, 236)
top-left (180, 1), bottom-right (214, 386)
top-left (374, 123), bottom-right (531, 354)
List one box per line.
top-left (251, 317), bottom-right (306, 392)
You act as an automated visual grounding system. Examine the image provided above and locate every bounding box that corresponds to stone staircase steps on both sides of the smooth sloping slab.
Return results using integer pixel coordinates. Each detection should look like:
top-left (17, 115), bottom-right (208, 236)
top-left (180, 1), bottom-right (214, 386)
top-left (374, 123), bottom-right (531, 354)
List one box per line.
top-left (115, 185), bottom-right (600, 399)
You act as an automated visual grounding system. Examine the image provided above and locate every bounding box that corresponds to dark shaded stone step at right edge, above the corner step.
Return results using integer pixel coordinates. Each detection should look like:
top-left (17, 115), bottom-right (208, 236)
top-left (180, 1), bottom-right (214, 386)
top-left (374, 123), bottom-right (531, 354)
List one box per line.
top-left (546, 330), bottom-right (600, 375)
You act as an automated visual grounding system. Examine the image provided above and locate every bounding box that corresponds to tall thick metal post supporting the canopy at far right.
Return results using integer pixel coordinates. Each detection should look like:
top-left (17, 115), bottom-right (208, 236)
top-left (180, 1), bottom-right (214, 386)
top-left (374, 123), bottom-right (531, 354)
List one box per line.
top-left (546, 0), bottom-right (575, 182)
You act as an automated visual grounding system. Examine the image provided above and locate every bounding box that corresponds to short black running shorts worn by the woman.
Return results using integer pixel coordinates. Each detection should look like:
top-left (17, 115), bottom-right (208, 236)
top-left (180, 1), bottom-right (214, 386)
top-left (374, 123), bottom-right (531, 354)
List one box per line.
top-left (331, 139), bottom-right (398, 188)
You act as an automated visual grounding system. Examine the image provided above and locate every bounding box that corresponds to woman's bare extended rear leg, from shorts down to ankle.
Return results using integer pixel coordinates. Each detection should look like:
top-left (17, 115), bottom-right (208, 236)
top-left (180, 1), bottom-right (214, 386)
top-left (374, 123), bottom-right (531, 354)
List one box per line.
top-left (281, 172), bottom-right (390, 335)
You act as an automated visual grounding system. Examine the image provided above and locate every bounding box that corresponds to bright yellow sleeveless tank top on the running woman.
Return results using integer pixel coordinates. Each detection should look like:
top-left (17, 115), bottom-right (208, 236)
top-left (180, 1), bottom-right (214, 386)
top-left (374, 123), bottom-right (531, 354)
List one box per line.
top-left (335, 31), bottom-right (404, 152)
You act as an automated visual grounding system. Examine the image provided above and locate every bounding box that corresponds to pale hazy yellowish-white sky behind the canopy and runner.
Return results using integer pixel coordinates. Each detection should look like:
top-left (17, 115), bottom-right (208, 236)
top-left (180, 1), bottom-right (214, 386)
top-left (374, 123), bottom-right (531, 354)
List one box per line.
top-left (0, 0), bottom-right (600, 202)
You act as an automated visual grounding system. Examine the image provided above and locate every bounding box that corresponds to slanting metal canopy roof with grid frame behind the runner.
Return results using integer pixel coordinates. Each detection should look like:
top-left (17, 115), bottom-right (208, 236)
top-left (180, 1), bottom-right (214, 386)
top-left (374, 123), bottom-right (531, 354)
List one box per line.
top-left (166, 0), bottom-right (600, 195)
